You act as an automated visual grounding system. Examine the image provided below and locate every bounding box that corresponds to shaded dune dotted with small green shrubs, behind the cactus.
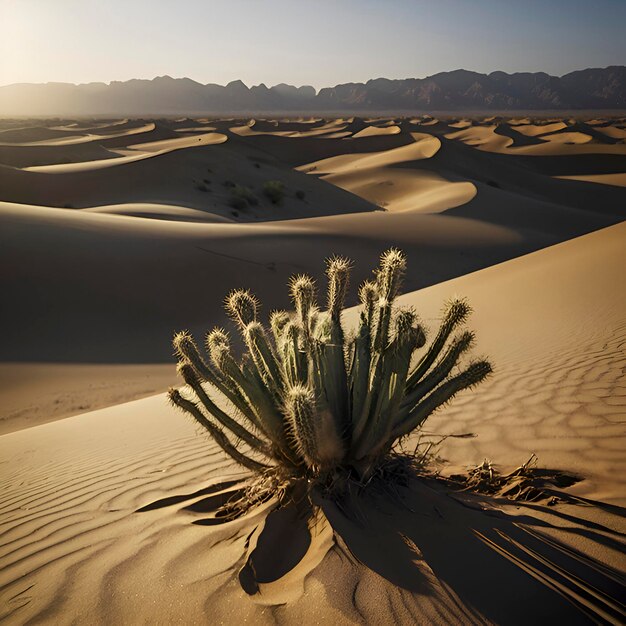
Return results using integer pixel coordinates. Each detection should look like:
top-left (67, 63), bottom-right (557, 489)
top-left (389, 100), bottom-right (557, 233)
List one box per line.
top-left (0, 133), bottom-right (374, 221)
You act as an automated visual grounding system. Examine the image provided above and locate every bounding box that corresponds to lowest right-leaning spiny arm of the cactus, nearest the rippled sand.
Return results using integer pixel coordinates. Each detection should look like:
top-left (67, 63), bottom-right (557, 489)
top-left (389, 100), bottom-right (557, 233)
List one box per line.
top-left (389, 361), bottom-right (492, 445)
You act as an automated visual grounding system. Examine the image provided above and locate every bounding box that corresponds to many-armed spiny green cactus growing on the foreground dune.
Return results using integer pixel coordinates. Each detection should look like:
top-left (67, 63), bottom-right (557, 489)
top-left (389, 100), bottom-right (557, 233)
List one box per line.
top-left (169, 248), bottom-right (491, 487)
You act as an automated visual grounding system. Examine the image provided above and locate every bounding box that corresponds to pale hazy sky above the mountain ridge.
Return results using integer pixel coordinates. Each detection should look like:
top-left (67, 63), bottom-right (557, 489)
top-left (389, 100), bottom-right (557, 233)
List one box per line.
top-left (0, 0), bottom-right (626, 89)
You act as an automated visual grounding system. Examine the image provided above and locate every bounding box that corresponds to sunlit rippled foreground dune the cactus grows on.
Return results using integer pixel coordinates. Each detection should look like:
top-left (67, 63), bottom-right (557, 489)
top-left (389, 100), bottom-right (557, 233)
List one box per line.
top-left (0, 225), bottom-right (626, 624)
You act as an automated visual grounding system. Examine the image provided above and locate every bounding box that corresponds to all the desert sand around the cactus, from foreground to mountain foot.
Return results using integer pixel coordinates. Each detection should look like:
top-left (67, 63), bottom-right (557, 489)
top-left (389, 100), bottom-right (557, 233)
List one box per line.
top-left (0, 118), bottom-right (626, 624)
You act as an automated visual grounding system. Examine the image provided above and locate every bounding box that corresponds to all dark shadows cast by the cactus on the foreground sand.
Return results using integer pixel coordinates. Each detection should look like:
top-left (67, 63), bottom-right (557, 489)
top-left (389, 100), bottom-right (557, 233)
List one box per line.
top-left (139, 470), bottom-right (626, 624)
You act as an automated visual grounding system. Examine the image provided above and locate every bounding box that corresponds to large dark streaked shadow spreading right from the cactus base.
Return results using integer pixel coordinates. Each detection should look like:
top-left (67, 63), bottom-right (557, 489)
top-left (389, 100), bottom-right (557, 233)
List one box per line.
top-left (318, 480), bottom-right (626, 624)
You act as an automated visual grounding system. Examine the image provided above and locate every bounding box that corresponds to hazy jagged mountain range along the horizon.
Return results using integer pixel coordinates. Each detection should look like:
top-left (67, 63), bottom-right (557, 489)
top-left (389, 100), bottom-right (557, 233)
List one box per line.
top-left (0, 66), bottom-right (626, 116)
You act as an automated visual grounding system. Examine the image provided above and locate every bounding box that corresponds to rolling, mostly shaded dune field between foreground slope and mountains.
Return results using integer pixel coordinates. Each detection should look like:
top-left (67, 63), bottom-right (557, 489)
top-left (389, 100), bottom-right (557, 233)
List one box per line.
top-left (0, 113), bottom-right (626, 429)
